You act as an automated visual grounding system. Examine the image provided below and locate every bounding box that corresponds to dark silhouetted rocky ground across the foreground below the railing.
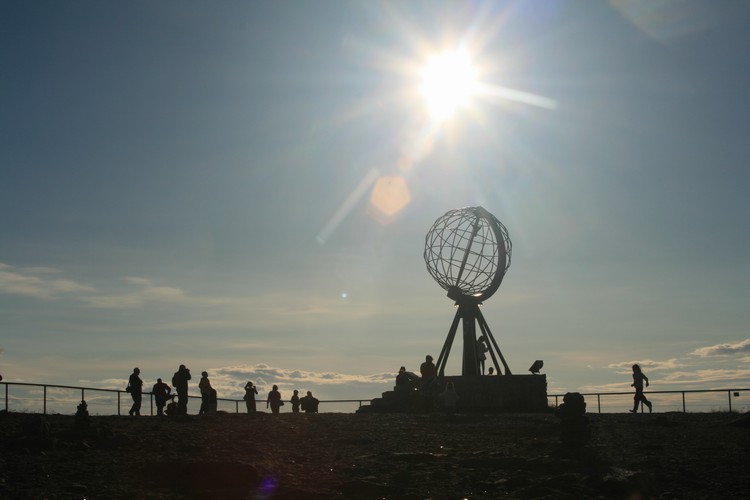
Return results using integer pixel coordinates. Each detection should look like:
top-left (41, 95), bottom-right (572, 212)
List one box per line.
top-left (0, 413), bottom-right (750, 499)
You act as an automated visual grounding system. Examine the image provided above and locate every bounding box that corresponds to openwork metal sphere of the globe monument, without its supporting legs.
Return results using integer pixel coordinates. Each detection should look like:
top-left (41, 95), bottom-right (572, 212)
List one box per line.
top-left (424, 207), bottom-right (512, 303)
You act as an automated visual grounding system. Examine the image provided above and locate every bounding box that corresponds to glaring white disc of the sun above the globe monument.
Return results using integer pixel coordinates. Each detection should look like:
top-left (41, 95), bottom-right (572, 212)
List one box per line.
top-left (420, 51), bottom-right (479, 121)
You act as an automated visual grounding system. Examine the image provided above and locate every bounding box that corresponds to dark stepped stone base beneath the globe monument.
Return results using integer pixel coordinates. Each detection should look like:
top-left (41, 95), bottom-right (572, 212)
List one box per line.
top-left (358, 375), bottom-right (549, 413)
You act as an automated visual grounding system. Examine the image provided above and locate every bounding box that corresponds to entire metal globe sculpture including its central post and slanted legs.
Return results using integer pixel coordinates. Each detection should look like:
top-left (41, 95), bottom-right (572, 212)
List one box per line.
top-left (424, 207), bottom-right (512, 377)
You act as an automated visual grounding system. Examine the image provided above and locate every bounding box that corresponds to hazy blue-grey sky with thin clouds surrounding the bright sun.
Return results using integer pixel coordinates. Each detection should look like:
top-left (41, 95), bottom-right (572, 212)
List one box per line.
top-left (0, 0), bottom-right (750, 410)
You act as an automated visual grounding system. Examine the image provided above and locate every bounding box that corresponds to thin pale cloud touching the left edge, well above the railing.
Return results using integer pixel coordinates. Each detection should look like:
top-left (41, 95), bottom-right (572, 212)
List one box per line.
top-left (0, 263), bottom-right (95, 299)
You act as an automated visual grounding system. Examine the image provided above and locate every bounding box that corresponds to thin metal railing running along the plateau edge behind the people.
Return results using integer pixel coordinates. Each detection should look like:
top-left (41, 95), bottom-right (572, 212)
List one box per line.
top-left (0, 382), bottom-right (750, 415)
